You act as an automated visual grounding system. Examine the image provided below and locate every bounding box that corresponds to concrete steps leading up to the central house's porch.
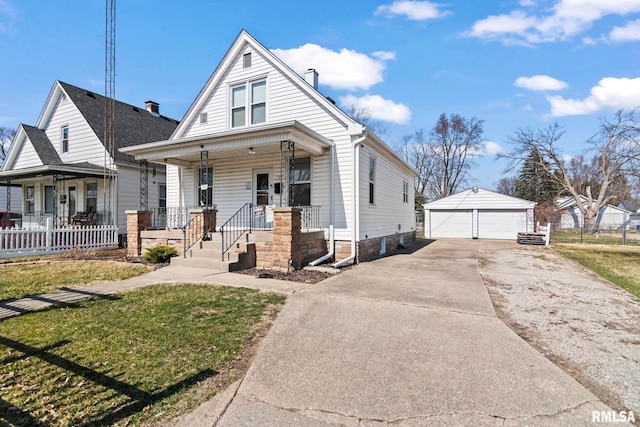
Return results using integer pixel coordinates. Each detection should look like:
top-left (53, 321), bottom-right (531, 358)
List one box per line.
top-left (171, 231), bottom-right (272, 271)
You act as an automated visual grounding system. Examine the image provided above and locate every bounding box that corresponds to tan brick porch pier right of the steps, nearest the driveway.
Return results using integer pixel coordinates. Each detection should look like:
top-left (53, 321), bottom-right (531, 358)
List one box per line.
top-left (271, 208), bottom-right (302, 273)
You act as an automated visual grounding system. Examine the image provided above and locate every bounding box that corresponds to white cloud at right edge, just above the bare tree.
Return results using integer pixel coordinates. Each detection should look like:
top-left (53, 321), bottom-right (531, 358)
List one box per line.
top-left (547, 77), bottom-right (640, 117)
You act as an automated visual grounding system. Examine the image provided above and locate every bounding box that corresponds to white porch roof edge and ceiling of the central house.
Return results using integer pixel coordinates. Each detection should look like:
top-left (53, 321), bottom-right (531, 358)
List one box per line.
top-left (120, 121), bottom-right (333, 166)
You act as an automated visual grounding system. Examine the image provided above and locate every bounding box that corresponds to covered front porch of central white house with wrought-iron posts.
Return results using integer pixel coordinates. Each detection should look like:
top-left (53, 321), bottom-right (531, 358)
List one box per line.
top-left (121, 121), bottom-right (333, 229)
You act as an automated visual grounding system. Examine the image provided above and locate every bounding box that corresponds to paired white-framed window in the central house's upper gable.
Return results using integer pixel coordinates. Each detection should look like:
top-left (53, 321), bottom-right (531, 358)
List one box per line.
top-left (231, 80), bottom-right (267, 128)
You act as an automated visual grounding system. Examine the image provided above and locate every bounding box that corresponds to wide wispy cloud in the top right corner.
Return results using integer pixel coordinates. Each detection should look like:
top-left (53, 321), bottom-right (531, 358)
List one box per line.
top-left (466, 0), bottom-right (640, 45)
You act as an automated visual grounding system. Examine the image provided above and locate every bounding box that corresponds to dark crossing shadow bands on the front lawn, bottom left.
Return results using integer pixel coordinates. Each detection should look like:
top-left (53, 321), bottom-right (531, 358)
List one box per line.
top-left (0, 336), bottom-right (218, 426)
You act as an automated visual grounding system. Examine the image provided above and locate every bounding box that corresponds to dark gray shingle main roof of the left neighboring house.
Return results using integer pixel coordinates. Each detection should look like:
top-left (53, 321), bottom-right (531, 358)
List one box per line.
top-left (59, 82), bottom-right (178, 164)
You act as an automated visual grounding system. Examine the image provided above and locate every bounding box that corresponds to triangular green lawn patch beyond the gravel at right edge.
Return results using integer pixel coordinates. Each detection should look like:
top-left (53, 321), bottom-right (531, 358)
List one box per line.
top-left (553, 244), bottom-right (640, 297)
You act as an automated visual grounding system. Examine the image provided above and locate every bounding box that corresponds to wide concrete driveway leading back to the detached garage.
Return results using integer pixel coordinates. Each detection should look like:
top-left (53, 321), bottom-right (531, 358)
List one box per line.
top-left (185, 240), bottom-right (609, 426)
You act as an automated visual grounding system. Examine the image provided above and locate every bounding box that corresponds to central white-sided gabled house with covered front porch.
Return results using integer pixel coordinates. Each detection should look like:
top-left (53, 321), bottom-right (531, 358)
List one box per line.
top-left (121, 30), bottom-right (416, 266)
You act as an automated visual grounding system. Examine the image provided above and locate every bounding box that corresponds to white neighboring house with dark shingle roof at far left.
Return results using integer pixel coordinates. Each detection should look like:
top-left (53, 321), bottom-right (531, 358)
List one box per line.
top-left (0, 81), bottom-right (178, 234)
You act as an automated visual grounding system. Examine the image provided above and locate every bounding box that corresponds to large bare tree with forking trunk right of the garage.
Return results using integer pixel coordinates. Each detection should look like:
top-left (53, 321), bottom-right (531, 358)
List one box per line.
top-left (500, 110), bottom-right (640, 227)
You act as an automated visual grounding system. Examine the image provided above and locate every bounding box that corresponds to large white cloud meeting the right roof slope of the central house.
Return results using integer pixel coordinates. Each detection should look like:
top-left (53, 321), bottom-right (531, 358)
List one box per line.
top-left (272, 43), bottom-right (395, 90)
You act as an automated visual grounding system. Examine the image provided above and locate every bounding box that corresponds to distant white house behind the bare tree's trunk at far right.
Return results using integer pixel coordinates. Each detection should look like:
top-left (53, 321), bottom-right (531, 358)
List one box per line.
top-left (556, 196), bottom-right (632, 229)
